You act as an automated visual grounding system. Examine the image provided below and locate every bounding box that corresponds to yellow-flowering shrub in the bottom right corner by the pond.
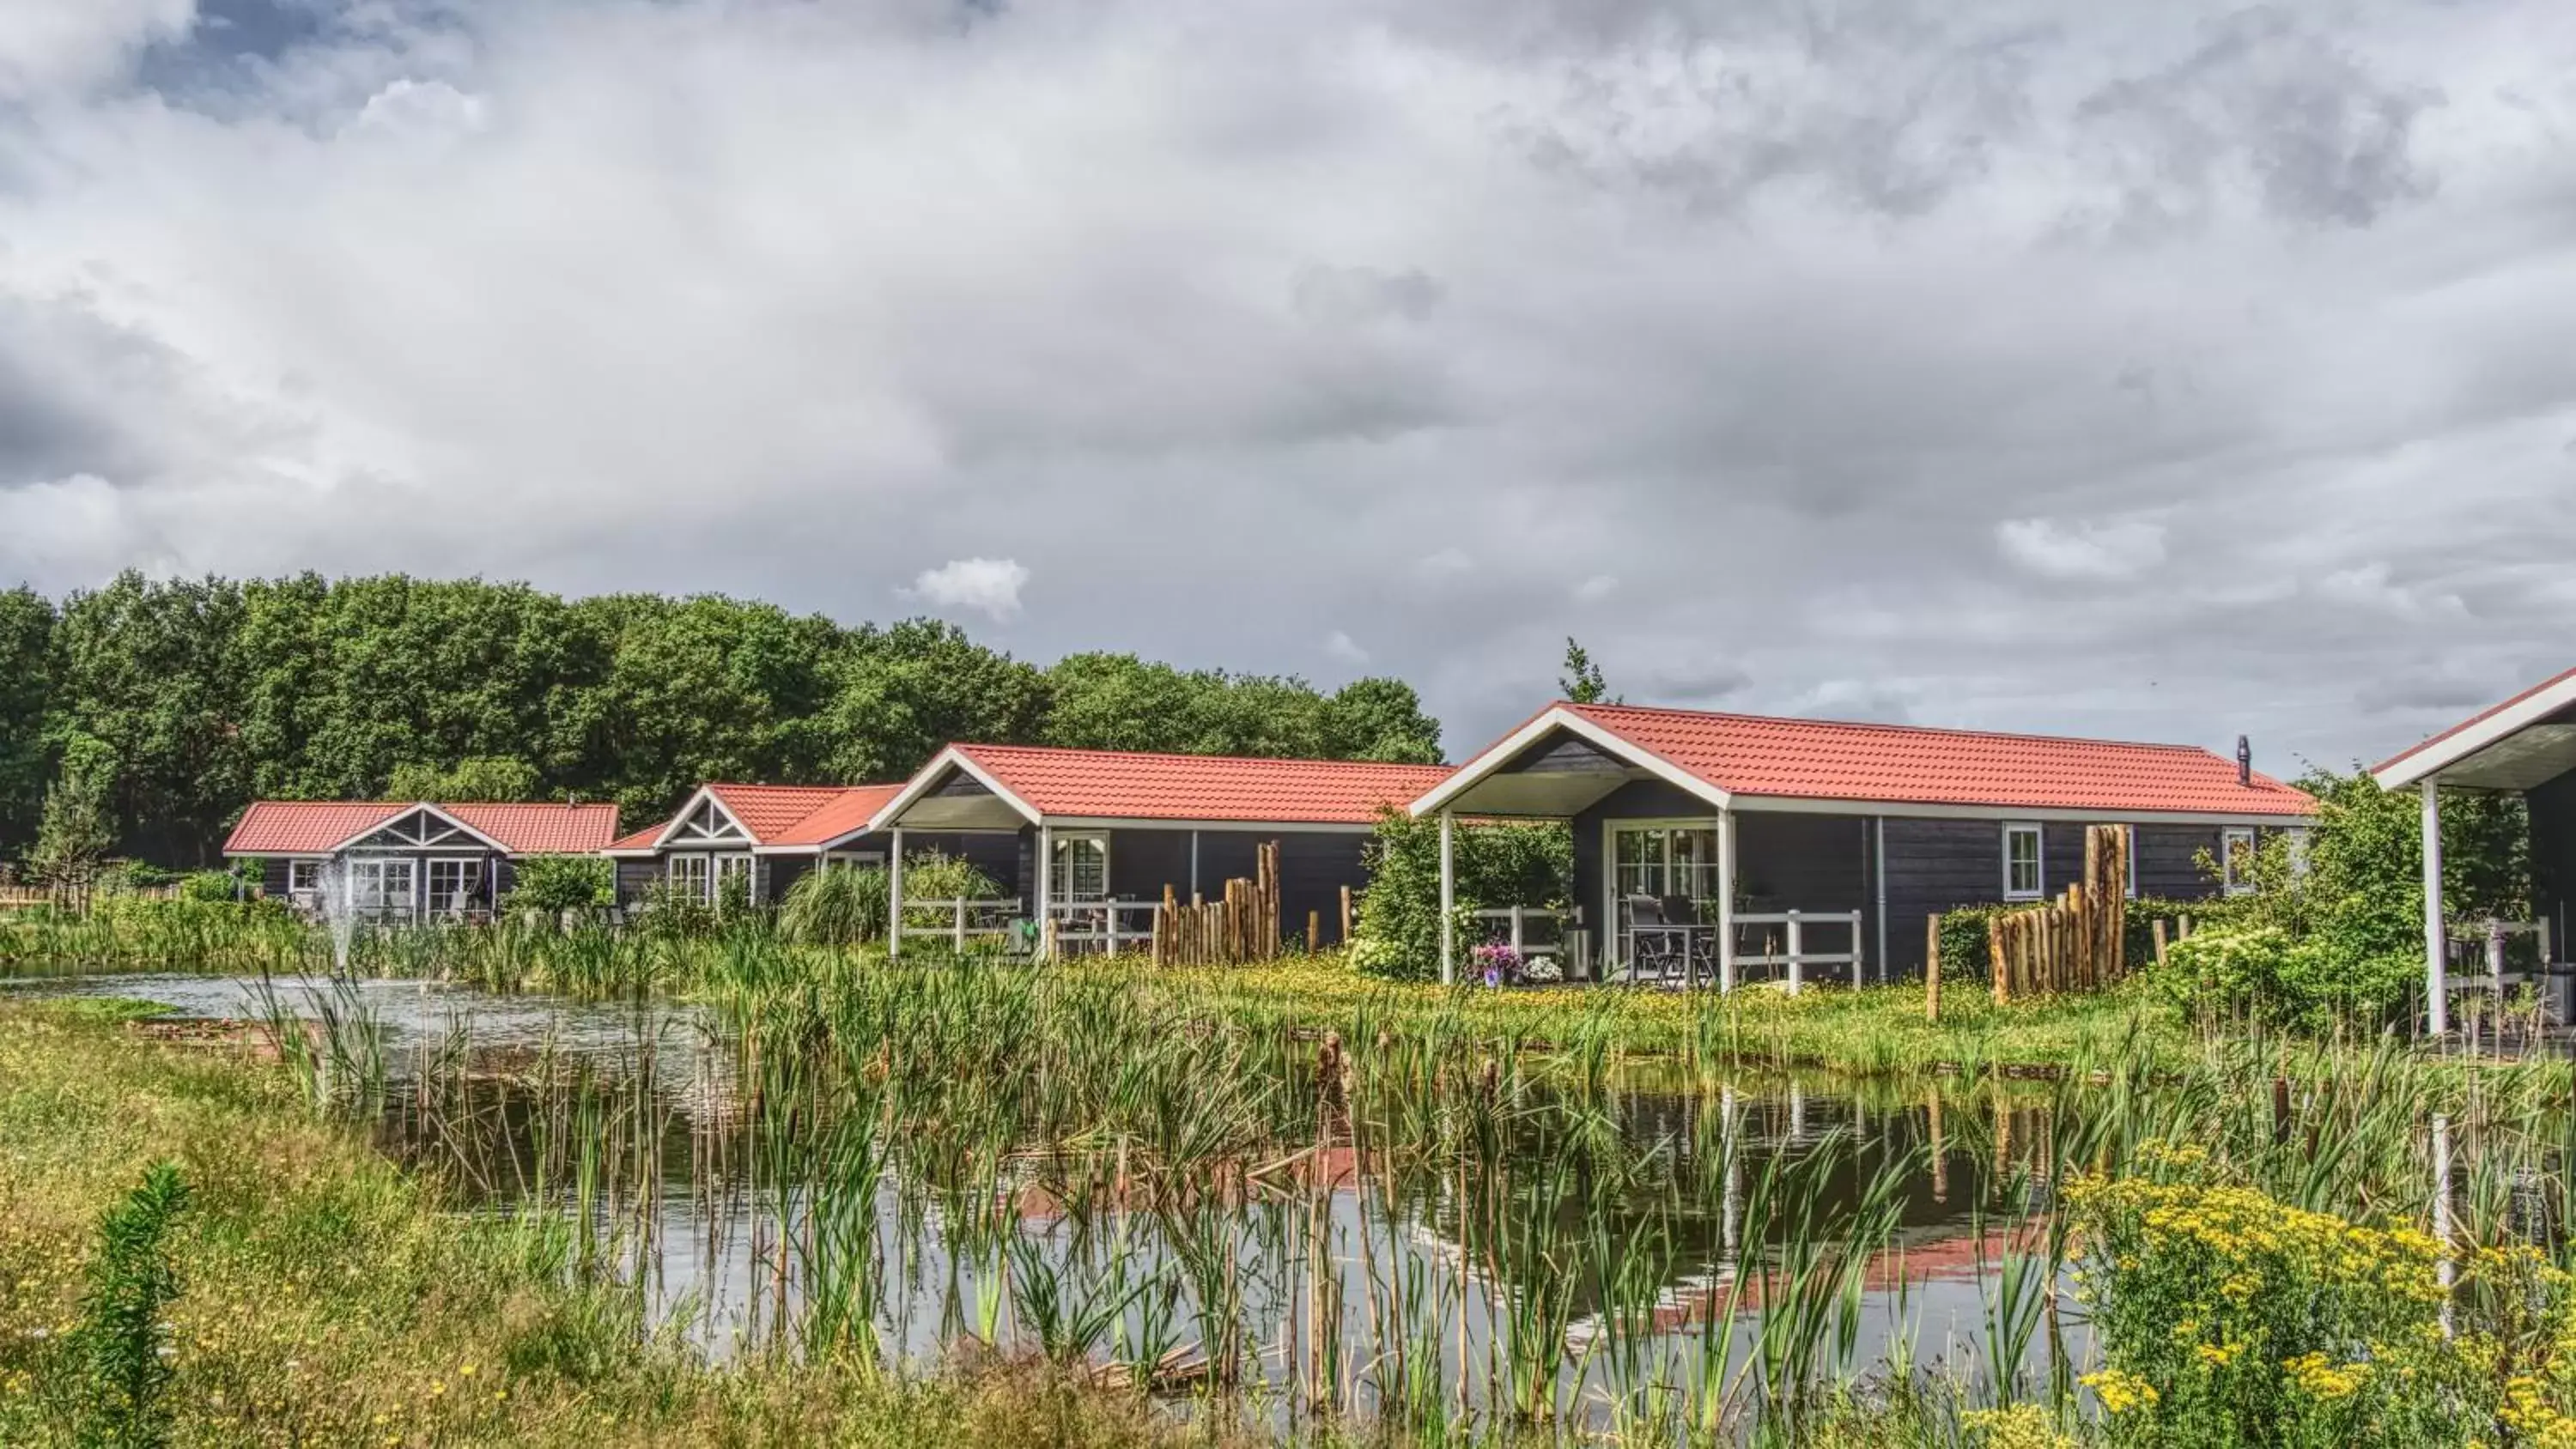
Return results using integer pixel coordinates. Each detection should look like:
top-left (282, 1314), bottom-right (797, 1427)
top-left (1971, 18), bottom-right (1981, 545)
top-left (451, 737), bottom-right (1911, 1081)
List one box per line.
top-left (2069, 1168), bottom-right (2576, 1446)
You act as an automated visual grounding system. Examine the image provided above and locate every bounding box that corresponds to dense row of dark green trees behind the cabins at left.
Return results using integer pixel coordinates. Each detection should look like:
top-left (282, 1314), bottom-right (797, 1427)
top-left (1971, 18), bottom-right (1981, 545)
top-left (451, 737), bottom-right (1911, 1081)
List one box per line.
top-left (0, 572), bottom-right (1440, 864)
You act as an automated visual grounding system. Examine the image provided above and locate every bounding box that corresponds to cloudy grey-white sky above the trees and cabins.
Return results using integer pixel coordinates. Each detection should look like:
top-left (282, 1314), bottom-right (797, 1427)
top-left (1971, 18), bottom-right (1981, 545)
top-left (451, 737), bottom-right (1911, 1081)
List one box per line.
top-left (0, 0), bottom-right (2576, 769)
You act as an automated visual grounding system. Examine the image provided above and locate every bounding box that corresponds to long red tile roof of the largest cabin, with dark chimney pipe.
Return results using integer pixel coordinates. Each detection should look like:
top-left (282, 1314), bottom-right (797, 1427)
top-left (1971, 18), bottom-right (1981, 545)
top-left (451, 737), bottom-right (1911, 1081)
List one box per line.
top-left (1558, 706), bottom-right (2316, 815)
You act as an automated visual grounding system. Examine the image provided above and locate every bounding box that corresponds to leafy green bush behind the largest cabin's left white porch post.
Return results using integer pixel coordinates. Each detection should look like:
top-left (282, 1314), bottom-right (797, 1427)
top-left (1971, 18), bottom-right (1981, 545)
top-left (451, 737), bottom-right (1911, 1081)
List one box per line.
top-left (1350, 810), bottom-right (1574, 980)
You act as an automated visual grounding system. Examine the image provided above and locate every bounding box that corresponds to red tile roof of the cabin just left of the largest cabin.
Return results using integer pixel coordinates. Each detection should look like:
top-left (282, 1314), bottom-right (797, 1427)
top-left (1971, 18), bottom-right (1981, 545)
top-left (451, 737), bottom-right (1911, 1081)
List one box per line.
top-left (956, 743), bottom-right (1450, 826)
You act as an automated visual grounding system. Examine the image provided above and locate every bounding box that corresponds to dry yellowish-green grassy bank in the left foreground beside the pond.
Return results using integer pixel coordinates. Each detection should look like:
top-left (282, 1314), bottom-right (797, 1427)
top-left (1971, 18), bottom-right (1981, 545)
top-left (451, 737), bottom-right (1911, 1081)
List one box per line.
top-left (0, 1003), bottom-right (1298, 1449)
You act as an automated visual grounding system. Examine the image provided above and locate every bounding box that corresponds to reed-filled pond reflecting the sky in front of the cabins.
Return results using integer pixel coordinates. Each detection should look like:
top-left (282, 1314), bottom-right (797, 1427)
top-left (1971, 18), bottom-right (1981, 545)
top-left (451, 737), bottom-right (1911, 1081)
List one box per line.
top-left (10, 975), bottom-right (2087, 1431)
